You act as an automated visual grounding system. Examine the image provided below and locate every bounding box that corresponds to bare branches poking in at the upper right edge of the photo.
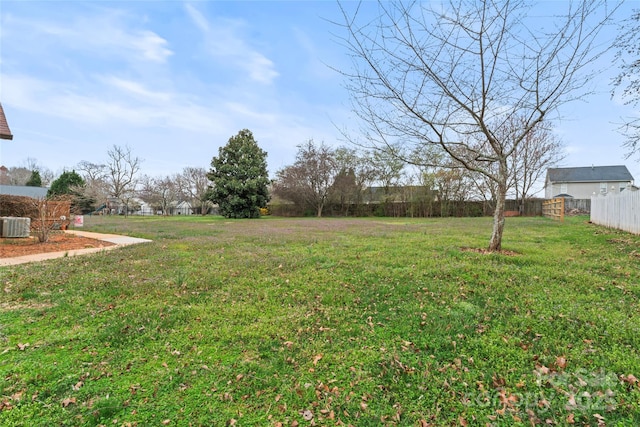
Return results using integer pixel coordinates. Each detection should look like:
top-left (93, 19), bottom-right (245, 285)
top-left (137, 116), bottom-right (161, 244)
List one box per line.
top-left (613, 10), bottom-right (640, 157)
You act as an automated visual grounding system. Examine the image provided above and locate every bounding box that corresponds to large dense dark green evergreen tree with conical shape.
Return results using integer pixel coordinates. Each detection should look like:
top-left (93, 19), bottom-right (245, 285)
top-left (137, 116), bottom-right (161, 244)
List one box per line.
top-left (207, 129), bottom-right (269, 218)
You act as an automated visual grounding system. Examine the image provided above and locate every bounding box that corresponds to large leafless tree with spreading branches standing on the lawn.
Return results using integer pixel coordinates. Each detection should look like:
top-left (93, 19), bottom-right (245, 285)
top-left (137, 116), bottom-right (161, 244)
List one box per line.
top-left (341, 0), bottom-right (612, 251)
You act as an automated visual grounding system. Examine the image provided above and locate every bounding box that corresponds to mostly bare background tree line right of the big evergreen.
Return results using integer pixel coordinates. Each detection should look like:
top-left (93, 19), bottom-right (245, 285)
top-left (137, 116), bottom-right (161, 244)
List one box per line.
top-left (272, 122), bottom-right (563, 216)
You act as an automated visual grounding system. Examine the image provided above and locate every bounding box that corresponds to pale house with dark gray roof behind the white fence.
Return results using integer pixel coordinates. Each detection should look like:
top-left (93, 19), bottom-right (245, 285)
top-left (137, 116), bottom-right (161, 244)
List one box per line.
top-left (544, 165), bottom-right (633, 199)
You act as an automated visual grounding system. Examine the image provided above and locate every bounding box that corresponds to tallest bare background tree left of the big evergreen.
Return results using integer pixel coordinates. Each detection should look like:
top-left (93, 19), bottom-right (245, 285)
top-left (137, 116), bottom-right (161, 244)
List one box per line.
top-left (106, 145), bottom-right (142, 215)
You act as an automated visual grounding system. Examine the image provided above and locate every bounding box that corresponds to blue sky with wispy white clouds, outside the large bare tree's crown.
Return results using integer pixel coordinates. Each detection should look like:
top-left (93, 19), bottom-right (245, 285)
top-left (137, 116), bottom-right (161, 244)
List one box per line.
top-left (0, 0), bottom-right (640, 191)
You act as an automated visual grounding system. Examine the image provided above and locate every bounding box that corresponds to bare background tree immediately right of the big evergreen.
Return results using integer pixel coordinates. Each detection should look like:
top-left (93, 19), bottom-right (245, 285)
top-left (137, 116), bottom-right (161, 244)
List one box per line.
top-left (273, 139), bottom-right (339, 217)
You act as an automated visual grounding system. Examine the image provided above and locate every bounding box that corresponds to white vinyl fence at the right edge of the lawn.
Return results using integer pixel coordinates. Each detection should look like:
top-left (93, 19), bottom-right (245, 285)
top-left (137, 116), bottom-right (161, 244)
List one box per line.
top-left (591, 190), bottom-right (640, 234)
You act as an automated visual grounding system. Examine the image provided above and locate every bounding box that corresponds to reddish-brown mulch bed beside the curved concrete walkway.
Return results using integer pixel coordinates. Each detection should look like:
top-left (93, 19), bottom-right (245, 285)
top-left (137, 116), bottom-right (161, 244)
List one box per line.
top-left (0, 233), bottom-right (114, 258)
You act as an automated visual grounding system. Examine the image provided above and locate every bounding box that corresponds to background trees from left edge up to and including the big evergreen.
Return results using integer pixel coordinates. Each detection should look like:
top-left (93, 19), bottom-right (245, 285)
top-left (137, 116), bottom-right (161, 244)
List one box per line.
top-left (0, 129), bottom-right (270, 218)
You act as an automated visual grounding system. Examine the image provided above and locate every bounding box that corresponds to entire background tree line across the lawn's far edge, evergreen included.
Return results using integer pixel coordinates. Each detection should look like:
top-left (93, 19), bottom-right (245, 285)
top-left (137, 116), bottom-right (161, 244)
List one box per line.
top-left (0, 123), bottom-right (562, 218)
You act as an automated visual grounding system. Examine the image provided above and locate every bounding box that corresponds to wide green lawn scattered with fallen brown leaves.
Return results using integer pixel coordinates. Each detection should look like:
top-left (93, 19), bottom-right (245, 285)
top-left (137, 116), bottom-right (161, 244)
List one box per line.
top-left (0, 217), bottom-right (640, 426)
